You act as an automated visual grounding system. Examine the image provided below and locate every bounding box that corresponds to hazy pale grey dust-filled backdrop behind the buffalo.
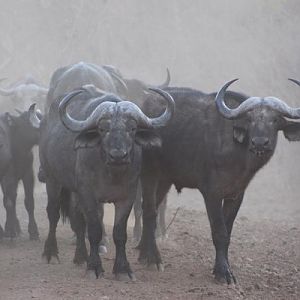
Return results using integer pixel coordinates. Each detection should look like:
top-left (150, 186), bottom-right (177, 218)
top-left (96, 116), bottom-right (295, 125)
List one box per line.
top-left (0, 0), bottom-right (300, 222)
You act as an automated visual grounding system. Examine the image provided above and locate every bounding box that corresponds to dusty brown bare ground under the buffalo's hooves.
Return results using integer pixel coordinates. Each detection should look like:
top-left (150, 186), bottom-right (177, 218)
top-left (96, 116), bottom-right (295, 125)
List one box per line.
top-left (0, 183), bottom-right (300, 300)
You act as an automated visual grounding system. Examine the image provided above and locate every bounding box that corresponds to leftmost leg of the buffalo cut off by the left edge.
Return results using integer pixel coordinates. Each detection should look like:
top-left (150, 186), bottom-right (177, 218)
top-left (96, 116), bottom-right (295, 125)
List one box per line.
top-left (1, 172), bottom-right (21, 238)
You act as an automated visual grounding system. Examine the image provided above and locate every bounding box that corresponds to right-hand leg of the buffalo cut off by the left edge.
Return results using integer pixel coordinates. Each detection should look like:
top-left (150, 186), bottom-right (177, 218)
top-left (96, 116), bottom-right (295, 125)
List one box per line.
top-left (22, 166), bottom-right (39, 240)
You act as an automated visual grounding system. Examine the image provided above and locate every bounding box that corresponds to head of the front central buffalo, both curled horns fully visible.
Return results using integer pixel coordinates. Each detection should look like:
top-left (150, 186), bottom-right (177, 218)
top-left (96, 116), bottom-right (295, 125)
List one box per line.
top-left (59, 89), bottom-right (175, 166)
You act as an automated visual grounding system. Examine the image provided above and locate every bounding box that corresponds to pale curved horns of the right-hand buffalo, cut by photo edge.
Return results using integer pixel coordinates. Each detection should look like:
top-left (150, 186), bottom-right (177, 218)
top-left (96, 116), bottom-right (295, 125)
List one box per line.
top-left (216, 79), bottom-right (300, 119)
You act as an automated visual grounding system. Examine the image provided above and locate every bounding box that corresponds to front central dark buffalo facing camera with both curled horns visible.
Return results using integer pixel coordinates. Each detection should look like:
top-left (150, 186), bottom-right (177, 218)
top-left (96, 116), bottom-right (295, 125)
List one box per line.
top-left (35, 84), bottom-right (174, 278)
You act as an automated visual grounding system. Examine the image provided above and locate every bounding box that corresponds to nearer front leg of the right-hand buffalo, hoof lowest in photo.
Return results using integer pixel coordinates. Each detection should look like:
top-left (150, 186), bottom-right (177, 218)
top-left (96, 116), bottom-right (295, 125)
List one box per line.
top-left (204, 195), bottom-right (235, 284)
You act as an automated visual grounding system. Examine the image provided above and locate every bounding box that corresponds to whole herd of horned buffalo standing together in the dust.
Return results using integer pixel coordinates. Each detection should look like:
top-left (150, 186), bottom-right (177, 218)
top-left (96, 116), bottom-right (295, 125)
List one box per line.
top-left (0, 62), bottom-right (300, 284)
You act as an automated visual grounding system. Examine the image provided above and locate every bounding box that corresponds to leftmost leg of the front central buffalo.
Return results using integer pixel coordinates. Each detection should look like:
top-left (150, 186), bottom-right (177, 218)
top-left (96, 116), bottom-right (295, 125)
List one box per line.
top-left (43, 180), bottom-right (62, 263)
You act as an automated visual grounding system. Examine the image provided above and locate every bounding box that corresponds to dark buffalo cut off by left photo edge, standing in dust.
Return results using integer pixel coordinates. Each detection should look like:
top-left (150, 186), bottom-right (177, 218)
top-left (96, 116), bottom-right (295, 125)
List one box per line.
top-left (0, 106), bottom-right (39, 240)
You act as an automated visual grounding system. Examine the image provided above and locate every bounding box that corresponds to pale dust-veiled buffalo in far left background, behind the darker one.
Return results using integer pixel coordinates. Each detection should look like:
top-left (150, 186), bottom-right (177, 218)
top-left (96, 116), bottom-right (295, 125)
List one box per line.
top-left (0, 75), bottom-right (48, 111)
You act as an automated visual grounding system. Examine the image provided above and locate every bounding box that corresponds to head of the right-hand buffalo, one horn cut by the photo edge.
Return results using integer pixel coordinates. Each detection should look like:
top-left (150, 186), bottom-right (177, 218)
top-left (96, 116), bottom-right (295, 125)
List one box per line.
top-left (216, 79), bottom-right (300, 157)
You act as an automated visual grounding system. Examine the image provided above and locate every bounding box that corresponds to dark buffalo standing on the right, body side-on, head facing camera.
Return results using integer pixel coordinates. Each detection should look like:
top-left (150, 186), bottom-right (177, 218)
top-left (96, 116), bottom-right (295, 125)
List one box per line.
top-left (139, 80), bottom-right (300, 283)
